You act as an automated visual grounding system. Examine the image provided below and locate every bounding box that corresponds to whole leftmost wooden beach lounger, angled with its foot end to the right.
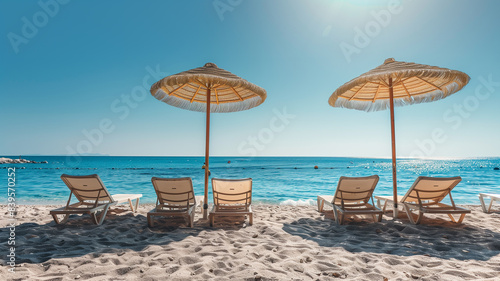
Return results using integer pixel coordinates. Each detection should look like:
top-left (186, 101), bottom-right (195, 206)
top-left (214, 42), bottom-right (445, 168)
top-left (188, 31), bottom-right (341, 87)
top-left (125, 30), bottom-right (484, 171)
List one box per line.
top-left (50, 174), bottom-right (142, 225)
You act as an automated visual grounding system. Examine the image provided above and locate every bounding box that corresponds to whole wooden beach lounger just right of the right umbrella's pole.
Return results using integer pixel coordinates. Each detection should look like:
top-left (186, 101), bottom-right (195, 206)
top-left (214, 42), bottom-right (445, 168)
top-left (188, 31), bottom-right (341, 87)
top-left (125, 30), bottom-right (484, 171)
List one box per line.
top-left (375, 177), bottom-right (471, 224)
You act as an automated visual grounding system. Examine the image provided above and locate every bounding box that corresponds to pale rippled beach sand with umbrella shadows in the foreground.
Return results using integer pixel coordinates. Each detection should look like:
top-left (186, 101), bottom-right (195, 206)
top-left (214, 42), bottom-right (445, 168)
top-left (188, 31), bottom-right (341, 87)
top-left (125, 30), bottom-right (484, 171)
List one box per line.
top-left (0, 205), bottom-right (500, 281)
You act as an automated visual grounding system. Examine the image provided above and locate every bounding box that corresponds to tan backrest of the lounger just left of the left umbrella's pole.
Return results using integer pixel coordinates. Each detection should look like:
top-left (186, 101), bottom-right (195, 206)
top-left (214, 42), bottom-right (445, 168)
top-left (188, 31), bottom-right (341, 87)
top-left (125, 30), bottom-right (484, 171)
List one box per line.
top-left (151, 177), bottom-right (196, 209)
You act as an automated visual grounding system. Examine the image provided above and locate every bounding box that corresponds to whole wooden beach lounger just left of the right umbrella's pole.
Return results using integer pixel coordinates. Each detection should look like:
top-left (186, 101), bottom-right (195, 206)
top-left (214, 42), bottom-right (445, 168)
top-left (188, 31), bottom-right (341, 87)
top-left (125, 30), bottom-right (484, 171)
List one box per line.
top-left (318, 175), bottom-right (383, 224)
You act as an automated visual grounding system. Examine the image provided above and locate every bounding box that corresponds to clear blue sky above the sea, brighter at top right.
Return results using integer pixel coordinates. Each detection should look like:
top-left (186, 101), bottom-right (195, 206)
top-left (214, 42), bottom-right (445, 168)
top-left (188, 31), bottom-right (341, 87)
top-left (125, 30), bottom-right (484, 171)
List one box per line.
top-left (0, 0), bottom-right (500, 158)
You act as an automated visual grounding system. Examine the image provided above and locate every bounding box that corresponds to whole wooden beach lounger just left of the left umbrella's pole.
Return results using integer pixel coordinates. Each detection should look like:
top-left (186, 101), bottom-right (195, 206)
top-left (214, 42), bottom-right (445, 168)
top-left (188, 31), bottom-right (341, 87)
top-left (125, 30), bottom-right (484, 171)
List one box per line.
top-left (147, 177), bottom-right (203, 227)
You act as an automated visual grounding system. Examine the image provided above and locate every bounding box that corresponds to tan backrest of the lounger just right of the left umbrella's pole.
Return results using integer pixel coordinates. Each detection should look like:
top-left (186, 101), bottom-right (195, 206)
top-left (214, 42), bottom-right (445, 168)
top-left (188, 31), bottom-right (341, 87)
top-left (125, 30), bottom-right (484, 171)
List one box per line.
top-left (212, 178), bottom-right (252, 209)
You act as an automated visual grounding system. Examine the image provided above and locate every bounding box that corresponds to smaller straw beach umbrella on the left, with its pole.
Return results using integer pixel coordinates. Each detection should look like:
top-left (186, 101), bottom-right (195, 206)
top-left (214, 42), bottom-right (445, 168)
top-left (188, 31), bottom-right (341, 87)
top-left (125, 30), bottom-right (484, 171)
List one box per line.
top-left (151, 63), bottom-right (267, 219)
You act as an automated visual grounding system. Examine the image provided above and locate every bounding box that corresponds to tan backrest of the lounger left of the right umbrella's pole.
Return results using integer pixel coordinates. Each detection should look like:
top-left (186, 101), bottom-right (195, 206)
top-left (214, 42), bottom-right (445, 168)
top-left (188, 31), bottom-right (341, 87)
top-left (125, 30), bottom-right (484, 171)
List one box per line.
top-left (333, 175), bottom-right (379, 206)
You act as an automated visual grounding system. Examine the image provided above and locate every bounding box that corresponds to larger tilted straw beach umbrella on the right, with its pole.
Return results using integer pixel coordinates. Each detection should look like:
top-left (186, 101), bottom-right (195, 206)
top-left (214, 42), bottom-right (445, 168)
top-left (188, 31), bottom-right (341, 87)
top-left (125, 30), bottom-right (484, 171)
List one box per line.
top-left (328, 58), bottom-right (470, 218)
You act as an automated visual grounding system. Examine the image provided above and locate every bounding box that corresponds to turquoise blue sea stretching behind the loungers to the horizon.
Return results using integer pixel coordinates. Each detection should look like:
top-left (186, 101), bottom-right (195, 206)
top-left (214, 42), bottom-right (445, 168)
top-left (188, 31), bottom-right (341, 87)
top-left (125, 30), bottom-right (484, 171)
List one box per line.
top-left (0, 156), bottom-right (500, 205)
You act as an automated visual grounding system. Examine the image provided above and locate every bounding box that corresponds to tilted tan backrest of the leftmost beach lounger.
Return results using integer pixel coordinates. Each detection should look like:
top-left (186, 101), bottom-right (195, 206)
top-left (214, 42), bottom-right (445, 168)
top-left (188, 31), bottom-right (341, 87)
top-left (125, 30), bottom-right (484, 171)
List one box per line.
top-left (61, 174), bottom-right (114, 204)
